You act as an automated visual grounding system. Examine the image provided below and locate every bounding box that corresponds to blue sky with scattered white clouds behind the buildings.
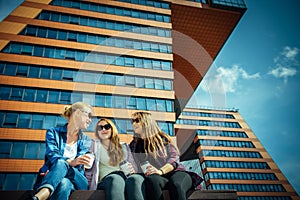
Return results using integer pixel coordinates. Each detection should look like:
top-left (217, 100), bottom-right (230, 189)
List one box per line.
top-left (0, 0), bottom-right (300, 194)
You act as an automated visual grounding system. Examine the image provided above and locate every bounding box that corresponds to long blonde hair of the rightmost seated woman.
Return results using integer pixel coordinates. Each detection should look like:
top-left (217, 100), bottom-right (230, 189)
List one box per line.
top-left (132, 111), bottom-right (178, 159)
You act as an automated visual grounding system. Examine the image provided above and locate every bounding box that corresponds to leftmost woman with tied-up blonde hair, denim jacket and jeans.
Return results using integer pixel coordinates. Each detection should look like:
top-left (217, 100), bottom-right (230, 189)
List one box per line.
top-left (31, 102), bottom-right (92, 200)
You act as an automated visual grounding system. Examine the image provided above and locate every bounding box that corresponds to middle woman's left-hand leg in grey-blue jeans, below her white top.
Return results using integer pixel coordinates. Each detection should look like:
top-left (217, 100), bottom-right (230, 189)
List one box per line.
top-left (97, 174), bottom-right (125, 200)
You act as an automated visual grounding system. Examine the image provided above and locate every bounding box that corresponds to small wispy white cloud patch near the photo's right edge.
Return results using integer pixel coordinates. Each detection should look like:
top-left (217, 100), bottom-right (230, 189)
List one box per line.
top-left (268, 46), bottom-right (299, 83)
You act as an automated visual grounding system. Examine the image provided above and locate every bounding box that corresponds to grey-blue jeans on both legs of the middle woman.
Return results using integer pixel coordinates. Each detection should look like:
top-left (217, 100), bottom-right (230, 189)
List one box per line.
top-left (97, 171), bottom-right (145, 200)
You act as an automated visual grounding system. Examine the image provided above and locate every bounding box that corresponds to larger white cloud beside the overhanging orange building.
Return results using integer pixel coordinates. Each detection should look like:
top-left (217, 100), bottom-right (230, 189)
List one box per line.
top-left (202, 65), bottom-right (260, 93)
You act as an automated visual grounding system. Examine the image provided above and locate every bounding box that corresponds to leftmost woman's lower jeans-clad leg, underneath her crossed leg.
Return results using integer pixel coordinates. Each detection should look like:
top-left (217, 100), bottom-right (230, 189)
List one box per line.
top-left (50, 178), bottom-right (75, 200)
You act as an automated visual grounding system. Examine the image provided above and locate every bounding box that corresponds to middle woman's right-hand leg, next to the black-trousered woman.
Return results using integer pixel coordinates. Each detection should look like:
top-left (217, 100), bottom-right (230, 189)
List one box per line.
top-left (125, 174), bottom-right (146, 200)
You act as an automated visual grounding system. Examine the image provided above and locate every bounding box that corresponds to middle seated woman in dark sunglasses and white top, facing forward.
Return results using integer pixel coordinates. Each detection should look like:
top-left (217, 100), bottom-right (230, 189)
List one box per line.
top-left (85, 118), bottom-right (143, 200)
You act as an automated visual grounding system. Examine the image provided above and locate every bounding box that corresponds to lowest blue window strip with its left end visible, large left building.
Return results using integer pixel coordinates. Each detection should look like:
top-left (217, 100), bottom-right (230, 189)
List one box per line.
top-left (2, 42), bottom-right (172, 71)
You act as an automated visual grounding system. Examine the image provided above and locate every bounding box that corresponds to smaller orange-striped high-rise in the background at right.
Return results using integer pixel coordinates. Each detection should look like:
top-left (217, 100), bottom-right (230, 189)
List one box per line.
top-left (175, 108), bottom-right (299, 200)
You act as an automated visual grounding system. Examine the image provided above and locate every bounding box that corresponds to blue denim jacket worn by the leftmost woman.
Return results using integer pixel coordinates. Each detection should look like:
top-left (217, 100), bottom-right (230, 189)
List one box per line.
top-left (39, 124), bottom-right (91, 173)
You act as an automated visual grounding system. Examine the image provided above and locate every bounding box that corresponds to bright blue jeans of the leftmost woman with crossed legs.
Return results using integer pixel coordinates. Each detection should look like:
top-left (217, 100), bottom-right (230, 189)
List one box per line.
top-left (37, 159), bottom-right (88, 199)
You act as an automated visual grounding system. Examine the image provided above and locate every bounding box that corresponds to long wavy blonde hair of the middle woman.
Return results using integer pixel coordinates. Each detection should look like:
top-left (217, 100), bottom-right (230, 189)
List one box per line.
top-left (95, 118), bottom-right (124, 166)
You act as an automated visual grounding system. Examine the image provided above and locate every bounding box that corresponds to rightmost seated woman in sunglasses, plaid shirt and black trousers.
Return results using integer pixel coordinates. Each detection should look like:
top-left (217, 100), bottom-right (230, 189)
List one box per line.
top-left (129, 112), bottom-right (202, 200)
